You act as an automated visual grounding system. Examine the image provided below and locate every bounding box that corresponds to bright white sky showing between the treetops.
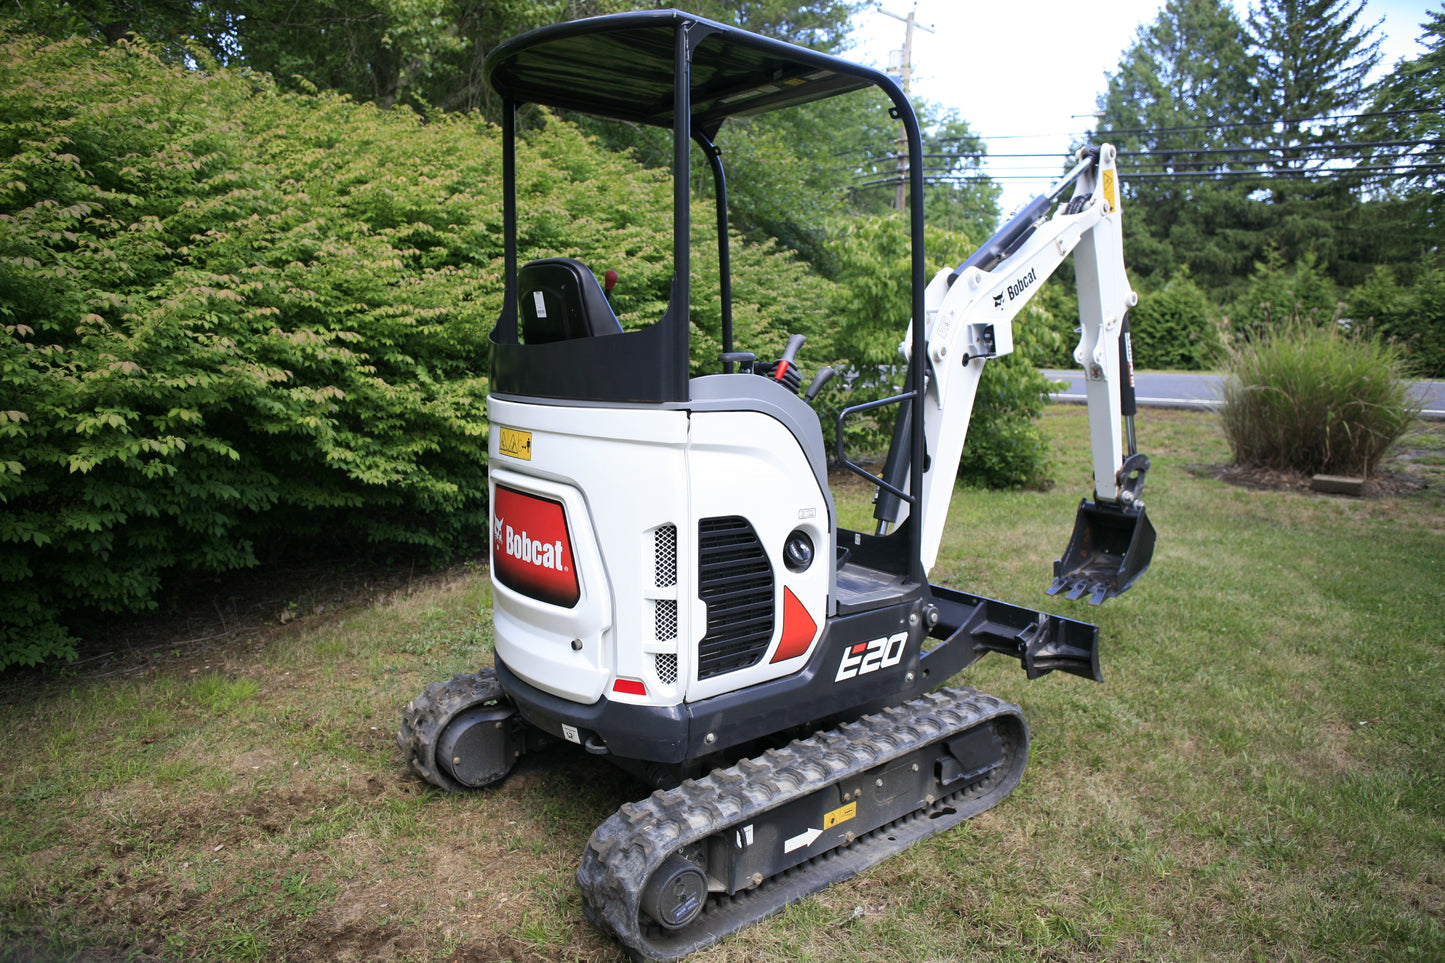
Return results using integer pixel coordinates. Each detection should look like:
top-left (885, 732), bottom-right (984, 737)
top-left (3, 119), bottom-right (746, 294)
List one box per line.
top-left (845, 0), bottom-right (1441, 214)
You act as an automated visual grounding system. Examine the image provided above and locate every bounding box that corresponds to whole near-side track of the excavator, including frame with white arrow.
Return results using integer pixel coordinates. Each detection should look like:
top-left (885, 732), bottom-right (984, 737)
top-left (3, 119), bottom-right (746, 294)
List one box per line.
top-left (577, 688), bottom-right (1029, 963)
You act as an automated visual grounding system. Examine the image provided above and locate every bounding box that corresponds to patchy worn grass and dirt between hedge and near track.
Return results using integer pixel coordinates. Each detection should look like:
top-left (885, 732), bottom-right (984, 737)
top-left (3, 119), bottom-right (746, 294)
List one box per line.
top-left (0, 565), bottom-right (621, 963)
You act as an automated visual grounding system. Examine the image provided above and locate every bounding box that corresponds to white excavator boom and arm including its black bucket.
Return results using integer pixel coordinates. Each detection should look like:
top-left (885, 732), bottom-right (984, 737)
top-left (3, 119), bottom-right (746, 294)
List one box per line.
top-left (880, 145), bottom-right (1155, 604)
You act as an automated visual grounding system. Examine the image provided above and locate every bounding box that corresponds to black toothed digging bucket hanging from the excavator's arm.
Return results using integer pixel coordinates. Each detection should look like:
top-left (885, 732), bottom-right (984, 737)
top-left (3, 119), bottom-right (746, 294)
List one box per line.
top-left (1048, 499), bottom-right (1155, 606)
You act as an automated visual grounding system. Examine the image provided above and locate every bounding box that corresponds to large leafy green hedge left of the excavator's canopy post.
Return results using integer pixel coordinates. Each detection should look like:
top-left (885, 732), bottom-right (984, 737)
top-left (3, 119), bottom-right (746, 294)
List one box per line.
top-left (0, 36), bottom-right (500, 667)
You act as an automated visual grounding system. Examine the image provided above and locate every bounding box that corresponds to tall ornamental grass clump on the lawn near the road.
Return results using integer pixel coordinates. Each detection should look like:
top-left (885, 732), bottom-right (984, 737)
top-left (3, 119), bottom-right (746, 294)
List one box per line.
top-left (1221, 322), bottom-right (1420, 477)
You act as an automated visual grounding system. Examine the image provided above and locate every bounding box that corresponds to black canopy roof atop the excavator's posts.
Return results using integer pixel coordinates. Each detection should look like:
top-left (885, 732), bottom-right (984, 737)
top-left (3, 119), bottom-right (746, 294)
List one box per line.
top-left (486, 10), bottom-right (893, 136)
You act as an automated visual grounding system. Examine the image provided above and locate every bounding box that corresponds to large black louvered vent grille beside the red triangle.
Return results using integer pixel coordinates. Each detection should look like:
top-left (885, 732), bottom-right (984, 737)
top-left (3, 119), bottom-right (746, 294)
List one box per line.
top-left (698, 516), bottom-right (773, 678)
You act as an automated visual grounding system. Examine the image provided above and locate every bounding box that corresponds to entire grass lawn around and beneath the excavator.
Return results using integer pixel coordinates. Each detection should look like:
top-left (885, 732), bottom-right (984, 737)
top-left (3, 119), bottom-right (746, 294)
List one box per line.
top-left (0, 406), bottom-right (1445, 963)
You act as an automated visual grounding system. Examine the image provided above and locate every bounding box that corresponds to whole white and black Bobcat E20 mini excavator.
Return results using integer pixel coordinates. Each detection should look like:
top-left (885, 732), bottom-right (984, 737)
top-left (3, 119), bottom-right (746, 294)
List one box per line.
top-left (397, 10), bottom-right (1155, 960)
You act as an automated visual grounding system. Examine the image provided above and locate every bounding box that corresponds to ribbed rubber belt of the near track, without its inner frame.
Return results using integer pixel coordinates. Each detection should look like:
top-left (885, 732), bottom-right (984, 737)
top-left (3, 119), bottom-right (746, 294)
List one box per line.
top-left (577, 688), bottom-right (1029, 963)
